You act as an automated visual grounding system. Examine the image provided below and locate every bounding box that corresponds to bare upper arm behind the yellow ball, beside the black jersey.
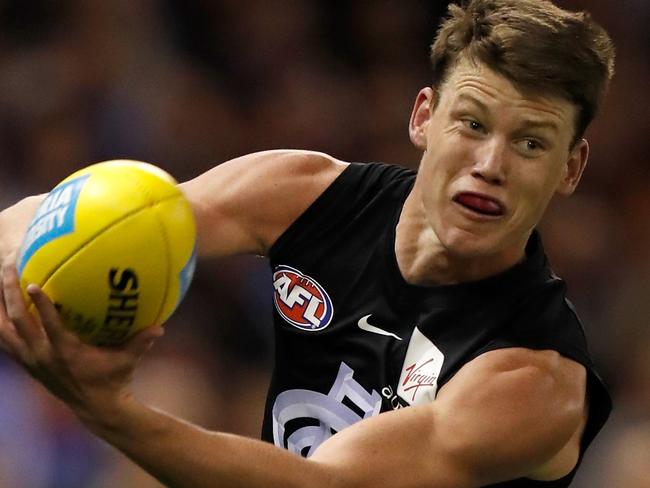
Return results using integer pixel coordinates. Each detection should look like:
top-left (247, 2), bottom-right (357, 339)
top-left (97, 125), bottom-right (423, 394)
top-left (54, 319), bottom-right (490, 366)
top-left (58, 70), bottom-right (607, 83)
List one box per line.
top-left (181, 150), bottom-right (346, 257)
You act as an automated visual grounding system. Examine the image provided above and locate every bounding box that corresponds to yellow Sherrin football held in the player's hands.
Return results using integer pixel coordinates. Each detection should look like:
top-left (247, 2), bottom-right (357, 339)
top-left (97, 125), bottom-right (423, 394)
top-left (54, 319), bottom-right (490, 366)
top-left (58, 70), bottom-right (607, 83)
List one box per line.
top-left (17, 160), bottom-right (196, 346)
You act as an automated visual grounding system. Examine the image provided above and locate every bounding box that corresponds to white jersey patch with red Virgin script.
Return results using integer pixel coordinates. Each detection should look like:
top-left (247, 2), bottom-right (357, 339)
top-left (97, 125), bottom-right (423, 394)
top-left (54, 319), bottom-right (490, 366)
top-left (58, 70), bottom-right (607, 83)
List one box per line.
top-left (397, 327), bottom-right (445, 405)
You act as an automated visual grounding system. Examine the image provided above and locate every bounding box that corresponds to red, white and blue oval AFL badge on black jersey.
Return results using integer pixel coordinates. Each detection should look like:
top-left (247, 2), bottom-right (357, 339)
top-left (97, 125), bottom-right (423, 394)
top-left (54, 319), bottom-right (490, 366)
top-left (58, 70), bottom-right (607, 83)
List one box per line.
top-left (273, 266), bottom-right (334, 331)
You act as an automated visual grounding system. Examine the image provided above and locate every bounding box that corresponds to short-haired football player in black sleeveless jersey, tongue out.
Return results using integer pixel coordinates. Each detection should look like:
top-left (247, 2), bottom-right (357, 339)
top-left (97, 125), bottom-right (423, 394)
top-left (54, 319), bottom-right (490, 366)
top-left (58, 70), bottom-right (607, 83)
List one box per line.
top-left (0, 0), bottom-right (613, 488)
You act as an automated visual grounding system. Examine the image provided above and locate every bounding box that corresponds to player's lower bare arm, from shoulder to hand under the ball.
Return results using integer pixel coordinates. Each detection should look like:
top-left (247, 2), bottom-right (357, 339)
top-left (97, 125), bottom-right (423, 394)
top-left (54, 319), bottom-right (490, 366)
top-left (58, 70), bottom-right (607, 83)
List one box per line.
top-left (0, 267), bottom-right (585, 488)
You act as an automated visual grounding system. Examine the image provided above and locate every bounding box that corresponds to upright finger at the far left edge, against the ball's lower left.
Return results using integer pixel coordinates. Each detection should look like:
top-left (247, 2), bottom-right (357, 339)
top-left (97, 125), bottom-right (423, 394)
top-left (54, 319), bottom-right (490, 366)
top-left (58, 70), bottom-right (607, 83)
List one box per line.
top-left (2, 265), bottom-right (45, 350)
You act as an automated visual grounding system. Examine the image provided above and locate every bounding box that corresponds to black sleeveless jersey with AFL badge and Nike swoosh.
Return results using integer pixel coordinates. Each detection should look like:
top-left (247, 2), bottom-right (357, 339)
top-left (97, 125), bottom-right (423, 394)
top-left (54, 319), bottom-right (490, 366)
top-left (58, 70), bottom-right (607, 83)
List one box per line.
top-left (262, 163), bottom-right (611, 488)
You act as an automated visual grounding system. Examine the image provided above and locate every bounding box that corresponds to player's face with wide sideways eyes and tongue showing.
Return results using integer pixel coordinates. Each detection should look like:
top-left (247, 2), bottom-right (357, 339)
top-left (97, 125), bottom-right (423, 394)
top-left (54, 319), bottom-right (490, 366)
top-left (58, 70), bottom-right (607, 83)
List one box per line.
top-left (410, 62), bottom-right (588, 264)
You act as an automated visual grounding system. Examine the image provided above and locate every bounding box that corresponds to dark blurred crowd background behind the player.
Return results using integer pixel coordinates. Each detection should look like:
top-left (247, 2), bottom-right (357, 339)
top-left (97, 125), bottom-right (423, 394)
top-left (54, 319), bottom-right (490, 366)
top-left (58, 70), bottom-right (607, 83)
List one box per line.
top-left (0, 0), bottom-right (650, 488)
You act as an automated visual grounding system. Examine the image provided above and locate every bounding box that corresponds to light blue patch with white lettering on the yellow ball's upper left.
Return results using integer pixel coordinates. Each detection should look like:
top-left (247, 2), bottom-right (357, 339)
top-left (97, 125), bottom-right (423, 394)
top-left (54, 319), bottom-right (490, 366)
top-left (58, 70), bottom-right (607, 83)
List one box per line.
top-left (17, 174), bottom-right (90, 273)
